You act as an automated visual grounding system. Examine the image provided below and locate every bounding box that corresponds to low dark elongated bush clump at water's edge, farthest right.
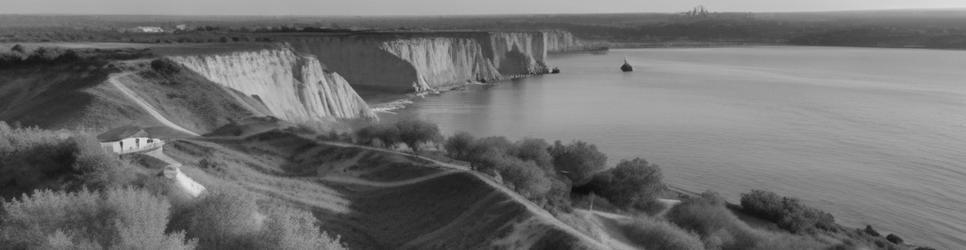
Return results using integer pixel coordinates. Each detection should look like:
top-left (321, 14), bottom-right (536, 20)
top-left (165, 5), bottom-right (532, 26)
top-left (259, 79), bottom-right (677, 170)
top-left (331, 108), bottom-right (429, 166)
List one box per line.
top-left (741, 190), bottom-right (835, 233)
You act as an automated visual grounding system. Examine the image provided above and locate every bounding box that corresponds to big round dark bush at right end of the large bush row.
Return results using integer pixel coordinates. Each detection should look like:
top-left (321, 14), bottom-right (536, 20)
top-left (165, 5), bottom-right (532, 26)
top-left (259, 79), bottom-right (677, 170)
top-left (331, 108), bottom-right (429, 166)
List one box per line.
top-left (592, 158), bottom-right (666, 209)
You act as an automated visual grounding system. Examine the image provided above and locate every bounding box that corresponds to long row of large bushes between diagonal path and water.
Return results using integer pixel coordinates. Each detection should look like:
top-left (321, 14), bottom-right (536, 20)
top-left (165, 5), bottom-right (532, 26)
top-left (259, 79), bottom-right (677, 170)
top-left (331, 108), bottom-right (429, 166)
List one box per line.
top-left (444, 129), bottom-right (666, 213)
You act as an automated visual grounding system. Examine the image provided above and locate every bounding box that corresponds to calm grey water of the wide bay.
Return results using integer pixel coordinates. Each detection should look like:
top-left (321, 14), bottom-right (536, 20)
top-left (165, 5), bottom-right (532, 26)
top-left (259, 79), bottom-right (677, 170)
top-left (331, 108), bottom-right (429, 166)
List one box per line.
top-left (386, 47), bottom-right (966, 249)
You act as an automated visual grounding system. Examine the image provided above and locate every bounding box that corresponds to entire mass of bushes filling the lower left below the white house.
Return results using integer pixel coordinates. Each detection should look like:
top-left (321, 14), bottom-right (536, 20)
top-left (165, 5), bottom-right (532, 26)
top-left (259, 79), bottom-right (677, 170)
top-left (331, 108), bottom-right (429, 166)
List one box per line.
top-left (0, 122), bottom-right (346, 250)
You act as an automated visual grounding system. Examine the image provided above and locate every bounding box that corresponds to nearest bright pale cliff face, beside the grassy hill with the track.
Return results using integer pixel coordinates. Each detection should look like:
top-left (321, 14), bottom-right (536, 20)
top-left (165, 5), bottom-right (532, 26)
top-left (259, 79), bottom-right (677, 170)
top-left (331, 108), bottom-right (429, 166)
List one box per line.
top-left (168, 47), bottom-right (375, 121)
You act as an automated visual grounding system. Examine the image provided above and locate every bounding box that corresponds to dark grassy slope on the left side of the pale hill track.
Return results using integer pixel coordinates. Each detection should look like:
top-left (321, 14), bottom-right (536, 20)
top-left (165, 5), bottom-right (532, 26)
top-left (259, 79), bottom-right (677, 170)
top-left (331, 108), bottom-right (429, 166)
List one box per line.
top-left (0, 55), bottom-right (151, 128)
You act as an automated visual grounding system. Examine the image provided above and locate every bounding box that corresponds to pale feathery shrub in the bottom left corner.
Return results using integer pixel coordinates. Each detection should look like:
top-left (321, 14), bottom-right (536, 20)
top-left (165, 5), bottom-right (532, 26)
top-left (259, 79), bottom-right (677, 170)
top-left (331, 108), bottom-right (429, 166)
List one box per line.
top-left (0, 188), bottom-right (194, 249)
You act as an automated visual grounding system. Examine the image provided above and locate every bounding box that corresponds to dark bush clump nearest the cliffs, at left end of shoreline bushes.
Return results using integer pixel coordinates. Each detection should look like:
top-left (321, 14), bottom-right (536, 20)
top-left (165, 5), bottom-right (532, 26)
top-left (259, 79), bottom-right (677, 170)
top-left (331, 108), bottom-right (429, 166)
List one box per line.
top-left (355, 120), bottom-right (443, 152)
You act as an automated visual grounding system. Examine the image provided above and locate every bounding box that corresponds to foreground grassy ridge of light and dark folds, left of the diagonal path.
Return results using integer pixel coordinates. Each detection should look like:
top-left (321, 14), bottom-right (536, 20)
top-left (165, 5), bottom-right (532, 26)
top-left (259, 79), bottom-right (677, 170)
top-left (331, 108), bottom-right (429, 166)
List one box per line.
top-left (161, 132), bottom-right (604, 249)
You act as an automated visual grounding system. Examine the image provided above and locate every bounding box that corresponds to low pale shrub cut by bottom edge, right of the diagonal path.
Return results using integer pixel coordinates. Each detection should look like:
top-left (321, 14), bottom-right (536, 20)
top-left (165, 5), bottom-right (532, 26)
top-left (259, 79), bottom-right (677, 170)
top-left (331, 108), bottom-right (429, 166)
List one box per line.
top-left (622, 218), bottom-right (704, 250)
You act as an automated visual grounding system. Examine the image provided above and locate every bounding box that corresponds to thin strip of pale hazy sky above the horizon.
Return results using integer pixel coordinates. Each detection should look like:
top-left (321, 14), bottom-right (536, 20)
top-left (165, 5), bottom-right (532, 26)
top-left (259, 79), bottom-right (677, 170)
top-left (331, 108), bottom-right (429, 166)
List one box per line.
top-left (0, 0), bottom-right (966, 15)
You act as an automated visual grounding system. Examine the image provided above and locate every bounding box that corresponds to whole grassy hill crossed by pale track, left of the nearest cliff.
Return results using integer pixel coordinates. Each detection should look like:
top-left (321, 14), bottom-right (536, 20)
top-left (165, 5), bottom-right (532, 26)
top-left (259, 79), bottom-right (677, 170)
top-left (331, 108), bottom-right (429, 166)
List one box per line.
top-left (0, 49), bottom-right (269, 136)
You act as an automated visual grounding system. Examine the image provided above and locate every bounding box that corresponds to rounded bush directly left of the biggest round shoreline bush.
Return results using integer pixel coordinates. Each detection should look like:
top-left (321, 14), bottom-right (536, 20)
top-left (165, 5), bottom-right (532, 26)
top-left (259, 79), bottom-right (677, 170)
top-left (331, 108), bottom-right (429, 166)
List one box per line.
top-left (550, 141), bottom-right (607, 186)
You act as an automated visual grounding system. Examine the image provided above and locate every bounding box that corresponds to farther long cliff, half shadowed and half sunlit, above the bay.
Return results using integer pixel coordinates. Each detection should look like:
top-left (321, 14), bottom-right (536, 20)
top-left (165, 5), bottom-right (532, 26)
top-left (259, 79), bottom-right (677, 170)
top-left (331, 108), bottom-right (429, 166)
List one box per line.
top-left (279, 32), bottom-right (547, 92)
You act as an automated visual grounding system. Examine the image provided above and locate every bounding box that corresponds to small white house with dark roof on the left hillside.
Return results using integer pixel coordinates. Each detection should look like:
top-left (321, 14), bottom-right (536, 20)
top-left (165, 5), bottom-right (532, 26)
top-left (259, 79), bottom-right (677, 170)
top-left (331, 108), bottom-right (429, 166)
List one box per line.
top-left (97, 126), bottom-right (164, 154)
